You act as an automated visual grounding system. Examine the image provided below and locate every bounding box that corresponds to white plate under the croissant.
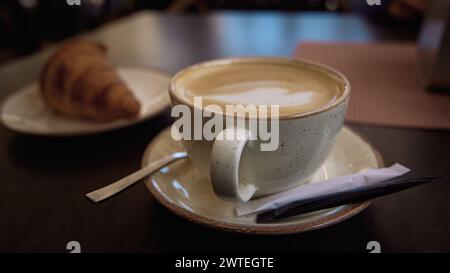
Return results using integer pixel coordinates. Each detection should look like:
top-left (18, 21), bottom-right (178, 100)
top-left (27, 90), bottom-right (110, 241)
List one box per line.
top-left (1, 67), bottom-right (171, 136)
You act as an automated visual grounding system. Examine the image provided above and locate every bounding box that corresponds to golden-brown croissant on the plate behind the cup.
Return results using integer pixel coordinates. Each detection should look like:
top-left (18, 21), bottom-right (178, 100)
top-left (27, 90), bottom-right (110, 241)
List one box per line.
top-left (40, 39), bottom-right (140, 121)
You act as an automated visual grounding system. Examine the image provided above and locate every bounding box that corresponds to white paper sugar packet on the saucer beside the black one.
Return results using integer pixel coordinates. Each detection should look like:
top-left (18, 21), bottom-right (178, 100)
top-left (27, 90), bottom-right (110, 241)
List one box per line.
top-left (236, 163), bottom-right (410, 216)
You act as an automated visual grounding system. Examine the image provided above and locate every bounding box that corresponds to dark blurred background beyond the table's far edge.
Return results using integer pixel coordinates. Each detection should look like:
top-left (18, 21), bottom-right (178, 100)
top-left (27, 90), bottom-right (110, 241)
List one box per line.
top-left (0, 0), bottom-right (427, 63)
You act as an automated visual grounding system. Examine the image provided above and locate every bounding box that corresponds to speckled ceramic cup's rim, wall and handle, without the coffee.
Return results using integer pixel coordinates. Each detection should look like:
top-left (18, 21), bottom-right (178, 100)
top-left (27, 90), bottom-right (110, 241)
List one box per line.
top-left (169, 57), bottom-right (350, 201)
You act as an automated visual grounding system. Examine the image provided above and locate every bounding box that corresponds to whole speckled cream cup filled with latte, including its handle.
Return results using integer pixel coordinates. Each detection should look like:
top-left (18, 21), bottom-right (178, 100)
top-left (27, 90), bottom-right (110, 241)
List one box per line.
top-left (169, 57), bottom-right (350, 201)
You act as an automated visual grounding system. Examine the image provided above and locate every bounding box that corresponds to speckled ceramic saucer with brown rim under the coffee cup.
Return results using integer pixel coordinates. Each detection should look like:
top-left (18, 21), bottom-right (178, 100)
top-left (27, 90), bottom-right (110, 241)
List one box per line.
top-left (142, 127), bottom-right (382, 234)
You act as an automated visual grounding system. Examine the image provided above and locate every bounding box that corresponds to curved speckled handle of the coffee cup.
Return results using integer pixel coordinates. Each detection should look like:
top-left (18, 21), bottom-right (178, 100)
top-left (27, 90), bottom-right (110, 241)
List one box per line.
top-left (210, 127), bottom-right (257, 202)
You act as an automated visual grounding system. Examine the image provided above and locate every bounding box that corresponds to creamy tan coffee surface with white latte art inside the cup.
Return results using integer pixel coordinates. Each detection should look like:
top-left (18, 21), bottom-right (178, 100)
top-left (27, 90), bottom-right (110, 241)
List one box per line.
top-left (175, 61), bottom-right (344, 115)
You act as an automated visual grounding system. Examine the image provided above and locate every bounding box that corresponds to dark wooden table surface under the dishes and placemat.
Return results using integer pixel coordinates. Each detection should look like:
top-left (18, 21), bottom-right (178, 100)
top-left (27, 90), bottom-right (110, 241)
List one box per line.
top-left (0, 12), bottom-right (450, 252)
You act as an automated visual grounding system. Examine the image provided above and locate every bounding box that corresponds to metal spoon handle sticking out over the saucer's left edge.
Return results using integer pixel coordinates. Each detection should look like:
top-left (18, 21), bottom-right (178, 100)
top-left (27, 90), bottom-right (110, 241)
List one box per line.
top-left (86, 152), bottom-right (187, 203)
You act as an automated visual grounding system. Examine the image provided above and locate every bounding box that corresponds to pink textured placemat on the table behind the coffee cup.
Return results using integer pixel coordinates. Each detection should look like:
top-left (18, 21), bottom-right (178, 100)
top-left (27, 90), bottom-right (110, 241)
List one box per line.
top-left (294, 42), bottom-right (450, 130)
